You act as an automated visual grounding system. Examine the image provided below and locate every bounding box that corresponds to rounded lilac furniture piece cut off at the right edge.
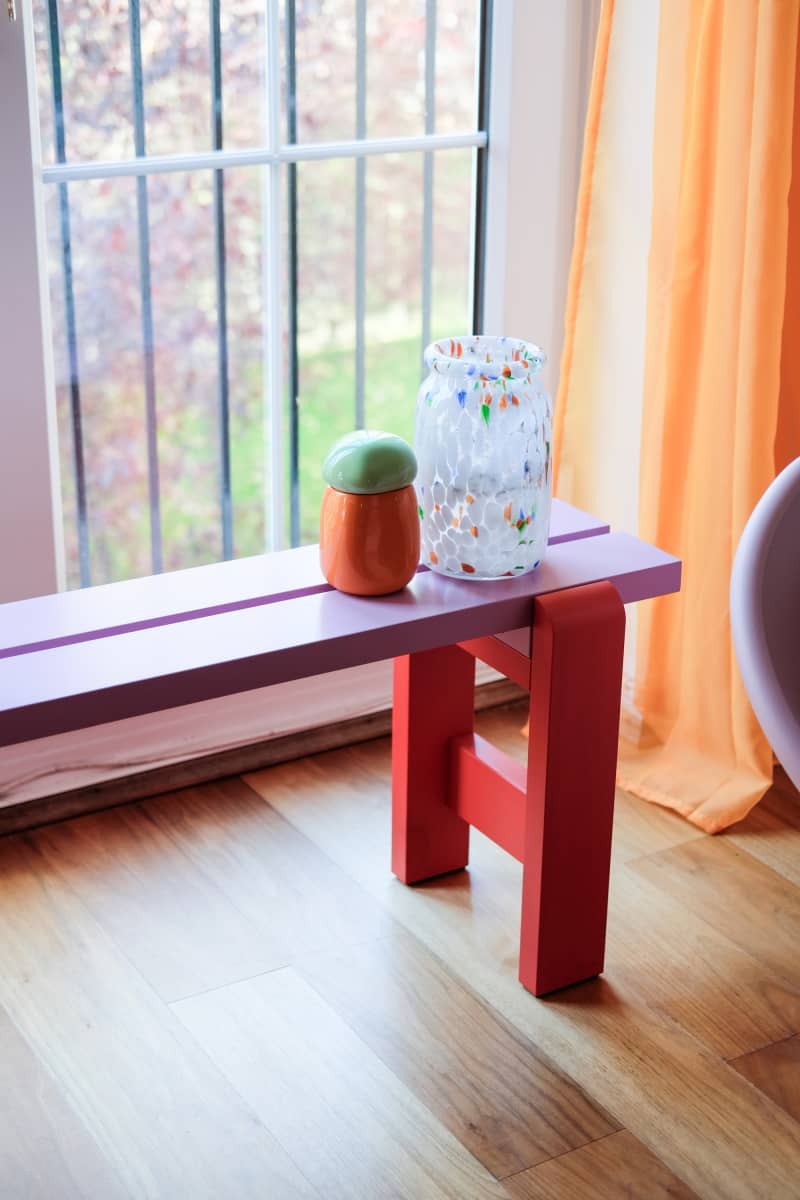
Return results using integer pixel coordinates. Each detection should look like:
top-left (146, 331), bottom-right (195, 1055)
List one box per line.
top-left (730, 458), bottom-right (800, 787)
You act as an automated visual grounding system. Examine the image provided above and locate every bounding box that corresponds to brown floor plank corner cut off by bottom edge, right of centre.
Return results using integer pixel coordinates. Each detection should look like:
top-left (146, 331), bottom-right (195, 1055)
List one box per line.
top-left (506, 1129), bottom-right (696, 1200)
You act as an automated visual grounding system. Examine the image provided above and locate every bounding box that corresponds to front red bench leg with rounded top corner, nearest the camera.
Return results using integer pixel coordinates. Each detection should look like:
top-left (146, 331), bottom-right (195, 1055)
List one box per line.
top-left (519, 582), bottom-right (625, 996)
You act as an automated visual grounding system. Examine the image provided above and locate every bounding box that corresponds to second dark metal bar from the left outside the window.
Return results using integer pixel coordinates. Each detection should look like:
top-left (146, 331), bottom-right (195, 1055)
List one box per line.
top-left (128, 0), bottom-right (163, 574)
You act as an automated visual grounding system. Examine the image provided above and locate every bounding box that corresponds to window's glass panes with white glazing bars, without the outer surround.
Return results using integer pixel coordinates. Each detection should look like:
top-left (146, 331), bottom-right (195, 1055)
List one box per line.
top-left (15, 0), bottom-right (486, 586)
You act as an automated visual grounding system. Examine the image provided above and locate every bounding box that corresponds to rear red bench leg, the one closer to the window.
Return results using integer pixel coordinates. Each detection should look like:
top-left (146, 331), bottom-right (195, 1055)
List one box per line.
top-left (392, 646), bottom-right (475, 883)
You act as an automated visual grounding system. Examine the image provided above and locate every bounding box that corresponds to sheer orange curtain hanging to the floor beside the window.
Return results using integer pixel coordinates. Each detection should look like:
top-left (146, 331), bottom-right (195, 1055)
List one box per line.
top-left (557, 0), bottom-right (800, 833)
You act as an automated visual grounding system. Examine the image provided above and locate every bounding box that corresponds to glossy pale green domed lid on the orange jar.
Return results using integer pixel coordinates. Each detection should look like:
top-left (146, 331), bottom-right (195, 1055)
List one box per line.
top-left (323, 430), bottom-right (416, 496)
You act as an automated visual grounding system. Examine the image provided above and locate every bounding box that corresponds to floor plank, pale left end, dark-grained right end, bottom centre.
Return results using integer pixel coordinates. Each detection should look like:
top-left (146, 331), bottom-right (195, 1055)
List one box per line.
top-left (297, 931), bottom-right (616, 1177)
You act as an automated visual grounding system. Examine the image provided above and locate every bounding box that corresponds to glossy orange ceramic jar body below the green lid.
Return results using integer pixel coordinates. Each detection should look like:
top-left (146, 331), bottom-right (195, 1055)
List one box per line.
top-left (319, 484), bottom-right (420, 596)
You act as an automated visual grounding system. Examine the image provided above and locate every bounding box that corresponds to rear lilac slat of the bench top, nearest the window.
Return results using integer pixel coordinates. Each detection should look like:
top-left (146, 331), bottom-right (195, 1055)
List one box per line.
top-left (0, 500), bottom-right (608, 659)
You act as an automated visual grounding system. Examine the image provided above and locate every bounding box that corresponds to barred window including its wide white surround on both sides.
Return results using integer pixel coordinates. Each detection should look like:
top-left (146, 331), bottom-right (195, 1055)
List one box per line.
top-left (0, 0), bottom-right (599, 601)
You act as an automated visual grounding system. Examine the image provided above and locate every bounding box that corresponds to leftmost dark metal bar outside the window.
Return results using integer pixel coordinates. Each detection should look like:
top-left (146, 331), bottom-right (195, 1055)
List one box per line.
top-left (47, 0), bottom-right (91, 587)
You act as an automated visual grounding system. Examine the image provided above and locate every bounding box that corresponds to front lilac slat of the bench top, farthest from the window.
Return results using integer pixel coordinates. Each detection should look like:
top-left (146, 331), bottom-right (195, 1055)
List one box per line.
top-left (0, 534), bottom-right (680, 745)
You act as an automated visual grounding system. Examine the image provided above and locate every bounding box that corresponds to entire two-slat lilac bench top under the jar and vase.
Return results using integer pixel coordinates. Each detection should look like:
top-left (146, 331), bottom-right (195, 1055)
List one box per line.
top-left (0, 505), bottom-right (680, 745)
